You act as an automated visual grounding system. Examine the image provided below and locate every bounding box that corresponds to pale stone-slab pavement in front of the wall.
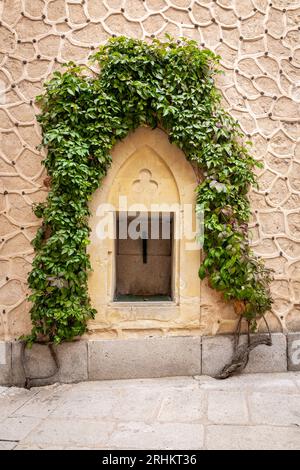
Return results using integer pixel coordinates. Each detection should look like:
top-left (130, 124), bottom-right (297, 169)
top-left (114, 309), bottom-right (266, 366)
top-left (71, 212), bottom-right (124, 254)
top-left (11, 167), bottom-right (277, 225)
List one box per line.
top-left (0, 373), bottom-right (300, 449)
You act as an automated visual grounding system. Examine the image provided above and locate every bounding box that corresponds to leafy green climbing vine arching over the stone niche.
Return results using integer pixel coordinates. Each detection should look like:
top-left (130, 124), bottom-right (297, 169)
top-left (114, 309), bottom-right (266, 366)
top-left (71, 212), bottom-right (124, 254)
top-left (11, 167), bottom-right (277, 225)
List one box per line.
top-left (26, 37), bottom-right (272, 343)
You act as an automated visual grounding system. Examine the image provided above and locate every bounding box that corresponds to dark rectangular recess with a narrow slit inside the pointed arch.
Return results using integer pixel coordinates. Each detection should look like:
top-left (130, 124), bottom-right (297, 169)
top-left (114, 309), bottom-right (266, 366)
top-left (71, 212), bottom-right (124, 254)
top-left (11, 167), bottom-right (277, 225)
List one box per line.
top-left (115, 212), bottom-right (174, 302)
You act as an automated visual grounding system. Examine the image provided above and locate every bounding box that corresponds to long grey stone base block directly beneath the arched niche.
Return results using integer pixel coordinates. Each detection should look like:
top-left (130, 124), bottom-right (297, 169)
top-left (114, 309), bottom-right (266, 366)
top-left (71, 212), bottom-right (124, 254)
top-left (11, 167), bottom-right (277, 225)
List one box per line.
top-left (88, 336), bottom-right (201, 380)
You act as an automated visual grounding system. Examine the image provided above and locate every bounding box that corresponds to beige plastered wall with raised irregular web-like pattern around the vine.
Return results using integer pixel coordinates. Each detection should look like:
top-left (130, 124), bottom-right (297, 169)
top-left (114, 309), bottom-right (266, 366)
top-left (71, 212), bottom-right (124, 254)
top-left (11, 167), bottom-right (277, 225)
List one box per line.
top-left (0, 0), bottom-right (300, 338)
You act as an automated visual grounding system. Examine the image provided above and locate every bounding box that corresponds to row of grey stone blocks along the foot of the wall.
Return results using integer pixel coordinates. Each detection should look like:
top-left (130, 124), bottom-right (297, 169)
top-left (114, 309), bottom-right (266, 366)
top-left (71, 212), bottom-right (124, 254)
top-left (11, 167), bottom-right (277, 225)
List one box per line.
top-left (0, 333), bottom-right (300, 386)
